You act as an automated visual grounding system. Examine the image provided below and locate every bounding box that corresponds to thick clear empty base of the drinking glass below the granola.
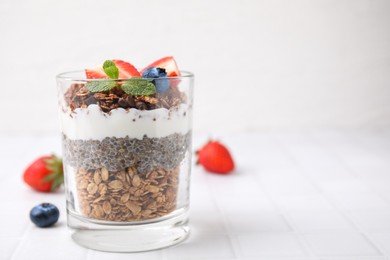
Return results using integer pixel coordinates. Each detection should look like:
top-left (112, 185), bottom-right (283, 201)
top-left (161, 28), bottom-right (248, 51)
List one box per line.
top-left (68, 210), bottom-right (189, 252)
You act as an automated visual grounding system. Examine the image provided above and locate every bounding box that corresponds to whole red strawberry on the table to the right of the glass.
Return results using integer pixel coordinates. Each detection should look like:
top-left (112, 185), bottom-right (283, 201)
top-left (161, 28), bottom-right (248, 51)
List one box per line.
top-left (196, 141), bottom-right (234, 174)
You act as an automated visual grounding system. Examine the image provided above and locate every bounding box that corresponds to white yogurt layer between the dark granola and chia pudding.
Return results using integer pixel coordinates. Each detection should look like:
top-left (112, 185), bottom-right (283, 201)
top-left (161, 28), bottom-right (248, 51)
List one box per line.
top-left (60, 104), bottom-right (192, 140)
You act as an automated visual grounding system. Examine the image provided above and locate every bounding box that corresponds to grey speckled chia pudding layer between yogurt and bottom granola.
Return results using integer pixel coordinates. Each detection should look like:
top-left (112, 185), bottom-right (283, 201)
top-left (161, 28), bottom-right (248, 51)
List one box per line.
top-left (62, 131), bottom-right (191, 173)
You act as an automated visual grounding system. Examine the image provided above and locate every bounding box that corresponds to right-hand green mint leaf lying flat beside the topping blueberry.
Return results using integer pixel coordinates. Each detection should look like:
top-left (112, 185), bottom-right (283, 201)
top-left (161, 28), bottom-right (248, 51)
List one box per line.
top-left (122, 77), bottom-right (156, 96)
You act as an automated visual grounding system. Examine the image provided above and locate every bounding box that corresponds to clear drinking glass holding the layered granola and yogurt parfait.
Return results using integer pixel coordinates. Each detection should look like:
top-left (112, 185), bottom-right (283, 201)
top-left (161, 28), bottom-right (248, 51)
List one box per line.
top-left (57, 71), bottom-right (194, 252)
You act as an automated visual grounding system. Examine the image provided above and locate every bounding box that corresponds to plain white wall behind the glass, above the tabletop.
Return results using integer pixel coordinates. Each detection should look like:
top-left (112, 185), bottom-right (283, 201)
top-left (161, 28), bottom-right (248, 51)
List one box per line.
top-left (0, 0), bottom-right (390, 133)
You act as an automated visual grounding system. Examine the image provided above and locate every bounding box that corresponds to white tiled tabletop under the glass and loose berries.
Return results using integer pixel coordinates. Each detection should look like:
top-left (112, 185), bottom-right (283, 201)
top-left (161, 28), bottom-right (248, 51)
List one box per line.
top-left (0, 131), bottom-right (390, 260)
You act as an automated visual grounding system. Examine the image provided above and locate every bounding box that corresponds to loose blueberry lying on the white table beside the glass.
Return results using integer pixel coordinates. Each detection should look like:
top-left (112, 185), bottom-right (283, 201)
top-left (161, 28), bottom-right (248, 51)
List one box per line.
top-left (30, 203), bottom-right (60, 227)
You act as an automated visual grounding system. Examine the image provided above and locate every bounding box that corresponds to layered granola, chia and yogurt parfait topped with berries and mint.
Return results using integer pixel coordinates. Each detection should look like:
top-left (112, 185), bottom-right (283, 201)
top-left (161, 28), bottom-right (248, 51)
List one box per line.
top-left (60, 57), bottom-right (192, 222)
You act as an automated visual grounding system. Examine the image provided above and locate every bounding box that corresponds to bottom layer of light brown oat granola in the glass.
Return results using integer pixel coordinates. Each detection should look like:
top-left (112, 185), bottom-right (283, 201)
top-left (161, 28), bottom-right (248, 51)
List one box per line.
top-left (76, 166), bottom-right (180, 222)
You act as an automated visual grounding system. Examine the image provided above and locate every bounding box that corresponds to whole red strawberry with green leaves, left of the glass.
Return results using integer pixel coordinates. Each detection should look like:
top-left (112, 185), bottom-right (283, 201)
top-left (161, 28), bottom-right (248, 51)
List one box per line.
top-left (23, 155), bottom-right (64, 192)
